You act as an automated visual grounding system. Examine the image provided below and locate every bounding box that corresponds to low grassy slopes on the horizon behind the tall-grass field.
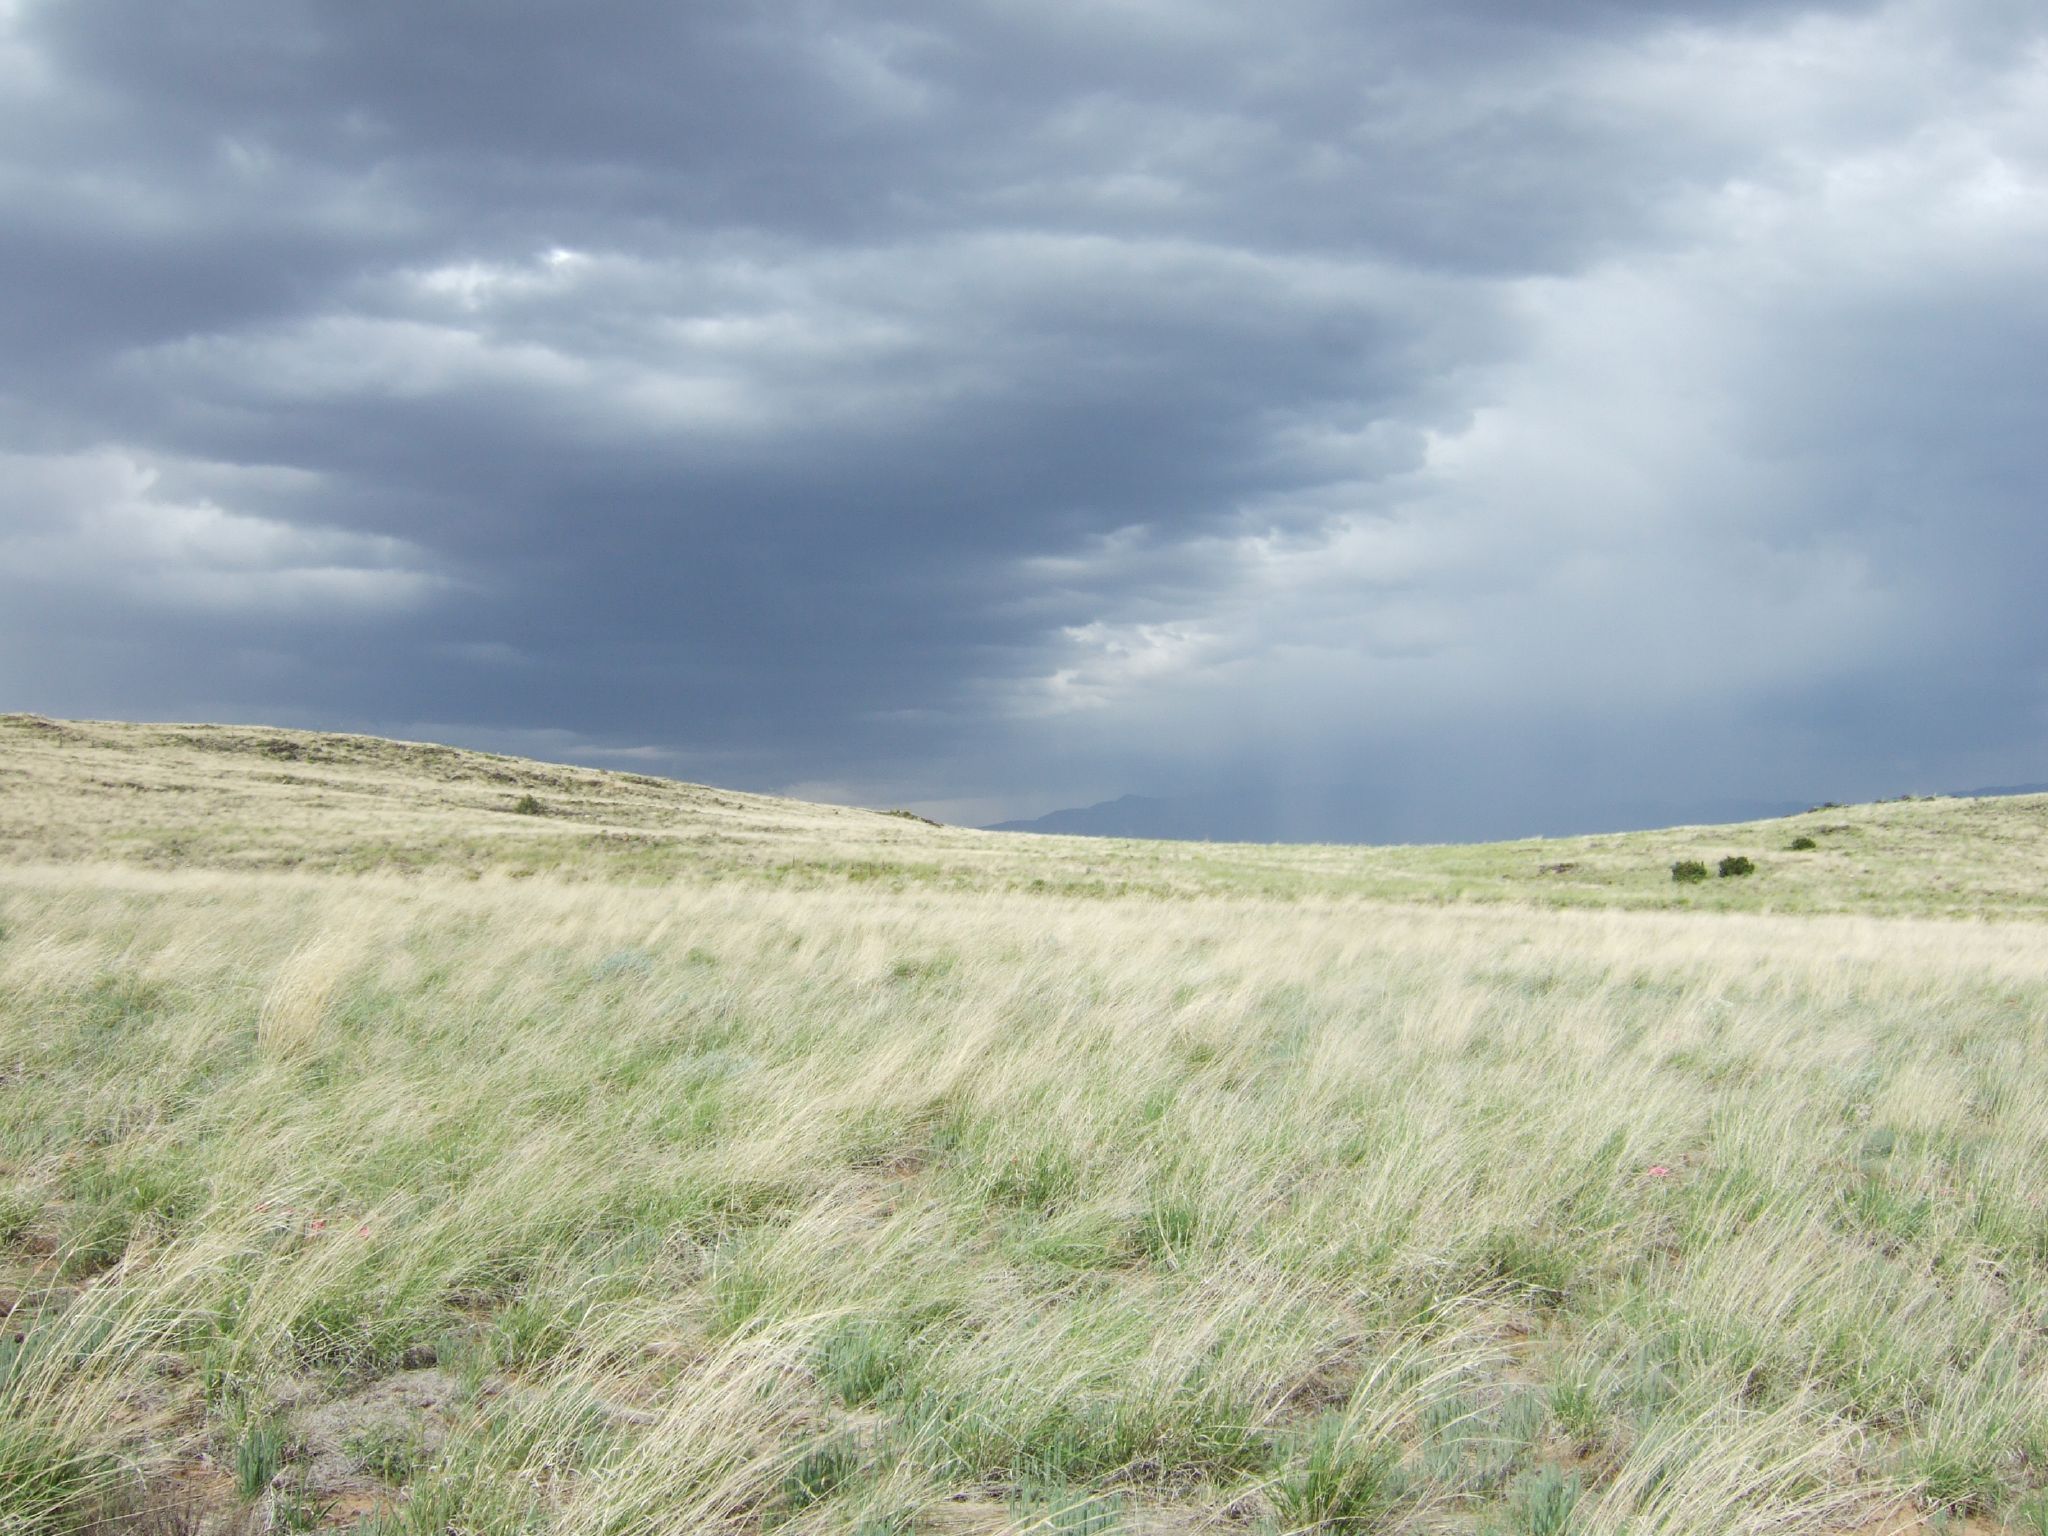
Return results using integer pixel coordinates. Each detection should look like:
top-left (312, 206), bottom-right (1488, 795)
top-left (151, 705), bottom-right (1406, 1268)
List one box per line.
top-left (12, 715), bottom-right (2048, 918)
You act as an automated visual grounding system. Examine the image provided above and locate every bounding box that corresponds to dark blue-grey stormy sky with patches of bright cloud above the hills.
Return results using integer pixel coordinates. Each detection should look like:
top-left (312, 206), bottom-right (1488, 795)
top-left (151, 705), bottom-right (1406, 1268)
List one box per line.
top-left (0, 0), bottom-right (2048, 838)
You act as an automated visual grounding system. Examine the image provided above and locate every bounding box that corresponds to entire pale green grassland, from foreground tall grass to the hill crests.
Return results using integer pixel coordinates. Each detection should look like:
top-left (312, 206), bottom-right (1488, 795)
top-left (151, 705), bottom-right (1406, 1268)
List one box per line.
top-left (0, 717), bottom-right (2048, 1536)
